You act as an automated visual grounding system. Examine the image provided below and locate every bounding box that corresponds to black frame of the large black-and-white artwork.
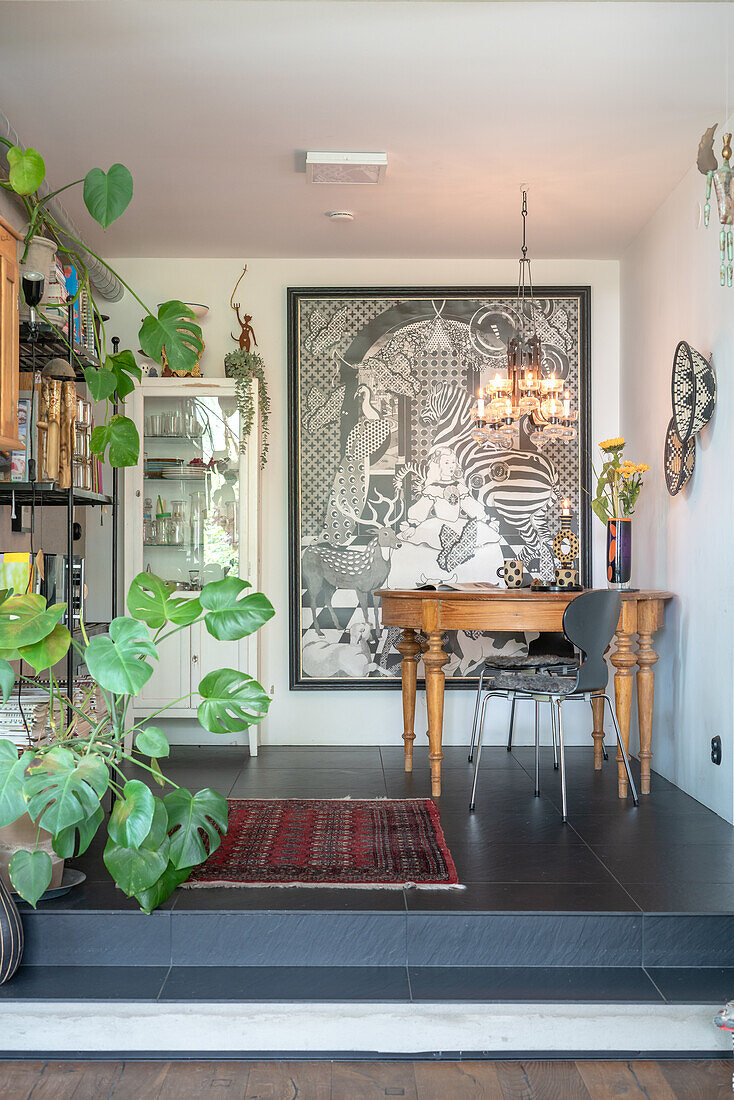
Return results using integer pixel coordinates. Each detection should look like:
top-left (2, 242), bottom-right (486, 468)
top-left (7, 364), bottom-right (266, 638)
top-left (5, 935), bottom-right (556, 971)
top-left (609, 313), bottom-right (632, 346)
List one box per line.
top-left (286, 285), bottom-right (592, 691)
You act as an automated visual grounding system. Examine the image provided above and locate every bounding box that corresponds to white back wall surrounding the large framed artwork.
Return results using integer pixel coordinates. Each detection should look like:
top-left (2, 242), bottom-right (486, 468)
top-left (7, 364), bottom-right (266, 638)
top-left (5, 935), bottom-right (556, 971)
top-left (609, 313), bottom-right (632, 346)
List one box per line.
top-left (108, 259), bottom-right (620, 744)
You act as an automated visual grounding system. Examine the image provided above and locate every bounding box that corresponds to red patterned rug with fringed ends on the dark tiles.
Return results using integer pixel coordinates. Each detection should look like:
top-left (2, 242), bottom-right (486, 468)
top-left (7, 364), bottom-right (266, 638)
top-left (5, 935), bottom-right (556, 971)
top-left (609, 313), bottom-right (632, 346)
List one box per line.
top-left (184, 799), bottom-right (459, 889)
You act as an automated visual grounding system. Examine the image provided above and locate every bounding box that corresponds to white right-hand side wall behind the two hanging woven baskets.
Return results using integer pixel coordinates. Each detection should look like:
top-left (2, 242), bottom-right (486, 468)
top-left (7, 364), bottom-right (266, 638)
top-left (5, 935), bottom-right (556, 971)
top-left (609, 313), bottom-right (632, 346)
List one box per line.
top-left (621, 146), bottom-right (734, 821)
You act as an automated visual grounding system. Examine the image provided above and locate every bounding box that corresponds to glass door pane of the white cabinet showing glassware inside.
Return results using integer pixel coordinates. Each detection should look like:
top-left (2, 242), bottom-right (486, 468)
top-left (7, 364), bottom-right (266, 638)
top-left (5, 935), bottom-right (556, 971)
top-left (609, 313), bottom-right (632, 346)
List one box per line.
top-left (142, 394), bottom-right (240, 591)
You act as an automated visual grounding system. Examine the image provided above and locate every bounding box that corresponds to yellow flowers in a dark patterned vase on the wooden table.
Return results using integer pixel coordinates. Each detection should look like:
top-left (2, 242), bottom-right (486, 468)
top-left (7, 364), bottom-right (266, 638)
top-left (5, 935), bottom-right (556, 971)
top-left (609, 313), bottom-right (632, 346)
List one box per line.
top-left (591, 436), bottom-right (650, 589)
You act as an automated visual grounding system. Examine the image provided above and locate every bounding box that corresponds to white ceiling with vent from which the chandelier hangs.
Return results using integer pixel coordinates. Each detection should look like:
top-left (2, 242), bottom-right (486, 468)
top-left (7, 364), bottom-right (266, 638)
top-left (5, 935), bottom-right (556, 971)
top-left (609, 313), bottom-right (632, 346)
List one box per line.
top-left (0, 0), bottom-right (734, 259)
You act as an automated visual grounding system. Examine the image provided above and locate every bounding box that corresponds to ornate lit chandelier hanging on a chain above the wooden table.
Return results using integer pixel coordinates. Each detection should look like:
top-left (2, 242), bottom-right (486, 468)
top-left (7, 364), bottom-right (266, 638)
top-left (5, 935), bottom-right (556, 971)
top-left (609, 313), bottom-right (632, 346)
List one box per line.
top-left (471, 190), bottom-right (579, 448)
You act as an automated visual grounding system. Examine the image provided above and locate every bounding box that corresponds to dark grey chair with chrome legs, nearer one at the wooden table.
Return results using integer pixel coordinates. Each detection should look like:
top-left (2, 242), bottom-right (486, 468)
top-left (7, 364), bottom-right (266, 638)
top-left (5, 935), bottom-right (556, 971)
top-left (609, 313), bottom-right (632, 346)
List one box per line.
top-left (469, 590), bottom-right (638, 821)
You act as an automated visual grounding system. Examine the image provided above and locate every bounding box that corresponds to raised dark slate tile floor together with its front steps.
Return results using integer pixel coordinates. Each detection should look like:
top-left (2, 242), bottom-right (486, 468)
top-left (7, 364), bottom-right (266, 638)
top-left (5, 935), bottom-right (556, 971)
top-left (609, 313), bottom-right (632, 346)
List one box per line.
top-left (0, 739), bottom-right (734, 1003)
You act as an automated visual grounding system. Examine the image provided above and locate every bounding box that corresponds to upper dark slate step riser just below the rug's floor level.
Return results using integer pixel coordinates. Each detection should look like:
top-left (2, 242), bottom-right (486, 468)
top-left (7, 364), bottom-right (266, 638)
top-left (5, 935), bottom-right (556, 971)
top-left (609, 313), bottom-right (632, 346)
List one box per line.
top-left (15, 906), bottom-right (734, 967)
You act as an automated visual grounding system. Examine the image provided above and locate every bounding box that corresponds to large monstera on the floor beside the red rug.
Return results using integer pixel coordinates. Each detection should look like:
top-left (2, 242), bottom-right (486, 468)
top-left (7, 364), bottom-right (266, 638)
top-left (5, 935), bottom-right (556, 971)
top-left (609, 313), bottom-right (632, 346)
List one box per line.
top-left (0, 573), bottom-right (274, 913)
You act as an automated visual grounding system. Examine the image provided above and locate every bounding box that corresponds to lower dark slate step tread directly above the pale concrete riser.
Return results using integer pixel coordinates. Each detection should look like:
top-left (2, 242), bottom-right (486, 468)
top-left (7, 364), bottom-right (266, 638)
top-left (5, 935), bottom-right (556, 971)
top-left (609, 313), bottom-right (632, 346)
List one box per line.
top-left (0, 966), bottom-right (734, 1004)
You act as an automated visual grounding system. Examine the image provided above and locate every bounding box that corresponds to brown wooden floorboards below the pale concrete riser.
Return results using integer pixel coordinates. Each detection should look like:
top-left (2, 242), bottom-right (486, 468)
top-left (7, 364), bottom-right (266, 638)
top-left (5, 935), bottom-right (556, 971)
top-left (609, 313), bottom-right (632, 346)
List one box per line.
top-left (0, 1059), bottom-right (732, 1100)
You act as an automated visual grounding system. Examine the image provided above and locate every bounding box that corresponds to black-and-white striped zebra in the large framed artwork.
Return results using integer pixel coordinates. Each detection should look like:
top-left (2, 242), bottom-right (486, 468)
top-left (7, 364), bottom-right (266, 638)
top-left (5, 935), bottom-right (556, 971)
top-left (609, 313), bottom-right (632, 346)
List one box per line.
top-left (420, 382), bottom-right (558, 579)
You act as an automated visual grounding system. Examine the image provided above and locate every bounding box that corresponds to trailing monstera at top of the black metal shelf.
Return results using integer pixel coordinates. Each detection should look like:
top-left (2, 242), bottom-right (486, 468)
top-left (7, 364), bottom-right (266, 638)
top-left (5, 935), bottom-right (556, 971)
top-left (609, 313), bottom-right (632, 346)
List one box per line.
top-left (0, 138), bottom-right (204, 468)
